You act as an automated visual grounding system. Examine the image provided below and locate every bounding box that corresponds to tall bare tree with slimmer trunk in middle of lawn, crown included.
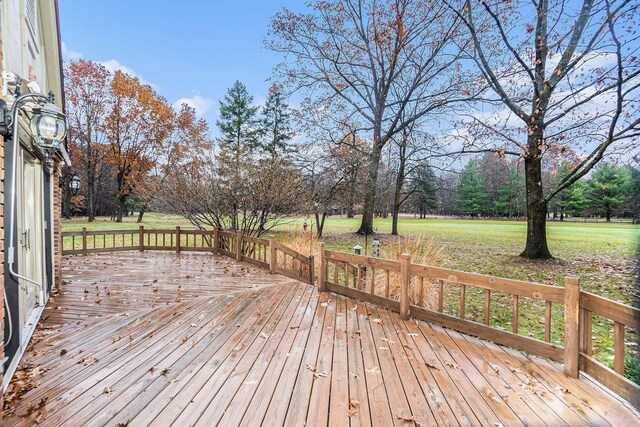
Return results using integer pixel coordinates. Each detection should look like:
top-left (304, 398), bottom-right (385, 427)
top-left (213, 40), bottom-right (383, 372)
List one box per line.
top-left (267, 0), bottom-right (471, 234)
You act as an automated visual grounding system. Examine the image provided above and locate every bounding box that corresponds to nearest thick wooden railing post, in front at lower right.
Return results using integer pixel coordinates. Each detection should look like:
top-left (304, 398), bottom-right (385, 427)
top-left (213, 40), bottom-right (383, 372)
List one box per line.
top-left (564, 276), bottom-right (580, 378)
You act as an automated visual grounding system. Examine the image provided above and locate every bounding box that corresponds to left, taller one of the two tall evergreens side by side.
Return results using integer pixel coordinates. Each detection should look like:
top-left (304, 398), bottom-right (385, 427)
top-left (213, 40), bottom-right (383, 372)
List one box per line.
top-left (216, 81), bottom-right (260, 162)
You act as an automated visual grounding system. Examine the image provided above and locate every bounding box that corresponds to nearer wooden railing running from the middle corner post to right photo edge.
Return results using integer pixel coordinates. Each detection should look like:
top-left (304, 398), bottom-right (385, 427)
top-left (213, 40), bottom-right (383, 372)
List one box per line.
top-left (318, 243), bottom-right (640, 406)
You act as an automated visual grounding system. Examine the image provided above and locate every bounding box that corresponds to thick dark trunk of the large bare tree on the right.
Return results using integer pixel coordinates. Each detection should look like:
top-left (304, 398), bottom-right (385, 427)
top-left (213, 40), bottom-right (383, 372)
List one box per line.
top-left (520, 142), bottom-right (552, 259)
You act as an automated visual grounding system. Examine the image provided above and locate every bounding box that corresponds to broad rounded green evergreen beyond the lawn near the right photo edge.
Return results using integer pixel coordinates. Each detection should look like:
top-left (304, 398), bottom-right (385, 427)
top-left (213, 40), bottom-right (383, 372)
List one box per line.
top-left (585, 162), bottom-right (630, 222)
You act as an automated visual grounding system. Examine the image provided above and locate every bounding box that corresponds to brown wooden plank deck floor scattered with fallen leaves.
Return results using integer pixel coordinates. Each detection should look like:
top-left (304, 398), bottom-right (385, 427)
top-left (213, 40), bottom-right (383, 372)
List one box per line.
top-left (3, 252), bottom-right (640, 427)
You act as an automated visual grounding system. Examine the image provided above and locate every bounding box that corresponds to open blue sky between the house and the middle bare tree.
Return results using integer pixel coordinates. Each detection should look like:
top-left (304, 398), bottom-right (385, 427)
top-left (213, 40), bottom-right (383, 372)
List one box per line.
top-left (60, 0), bottom-right (304, 127)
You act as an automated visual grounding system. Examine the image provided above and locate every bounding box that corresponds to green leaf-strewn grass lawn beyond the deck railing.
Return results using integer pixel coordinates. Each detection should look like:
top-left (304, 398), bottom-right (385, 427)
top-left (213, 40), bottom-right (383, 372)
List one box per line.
top-left (63, 213), bottom-right (640, 381)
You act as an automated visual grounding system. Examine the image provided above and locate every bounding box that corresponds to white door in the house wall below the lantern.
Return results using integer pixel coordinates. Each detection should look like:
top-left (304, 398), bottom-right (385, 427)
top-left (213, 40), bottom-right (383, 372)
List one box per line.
top-left (17, 150), bottom-right (45, 338)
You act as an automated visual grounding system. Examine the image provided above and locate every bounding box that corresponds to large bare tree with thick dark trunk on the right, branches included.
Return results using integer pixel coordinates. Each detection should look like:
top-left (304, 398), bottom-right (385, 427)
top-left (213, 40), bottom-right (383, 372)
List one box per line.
top-left (448, 0), bottom-right (640, 259)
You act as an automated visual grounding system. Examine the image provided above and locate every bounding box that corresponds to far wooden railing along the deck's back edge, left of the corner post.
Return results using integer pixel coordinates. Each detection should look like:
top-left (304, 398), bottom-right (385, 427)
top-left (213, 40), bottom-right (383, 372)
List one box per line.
top-left (62, 226), bottom-right (314, 284)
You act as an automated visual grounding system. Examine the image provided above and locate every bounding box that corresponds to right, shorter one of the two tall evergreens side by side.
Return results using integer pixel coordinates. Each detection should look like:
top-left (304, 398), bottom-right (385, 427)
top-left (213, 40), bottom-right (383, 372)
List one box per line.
top-left (262, 88), bottom-right (293, 160)
